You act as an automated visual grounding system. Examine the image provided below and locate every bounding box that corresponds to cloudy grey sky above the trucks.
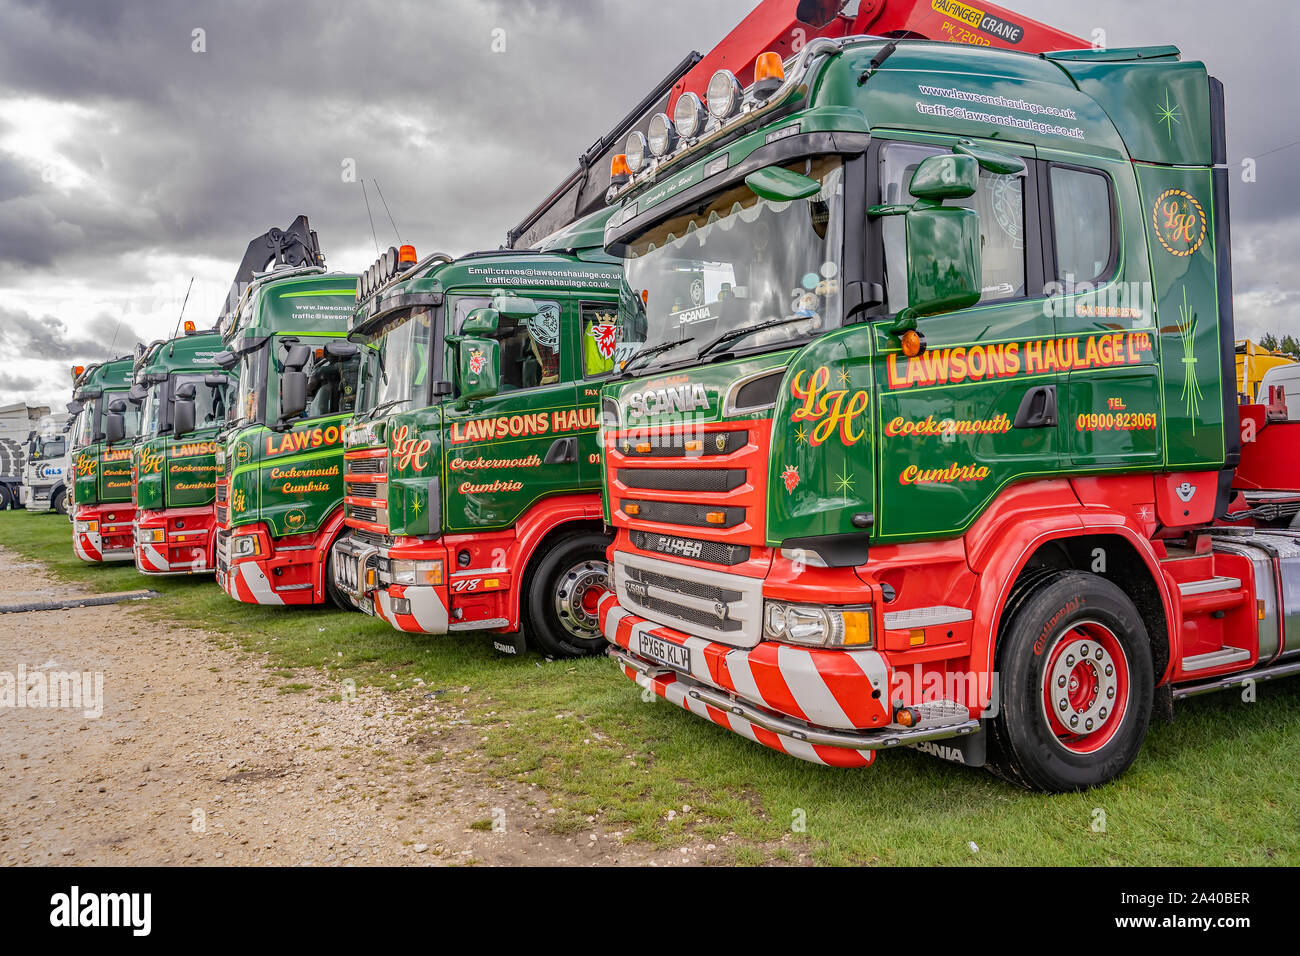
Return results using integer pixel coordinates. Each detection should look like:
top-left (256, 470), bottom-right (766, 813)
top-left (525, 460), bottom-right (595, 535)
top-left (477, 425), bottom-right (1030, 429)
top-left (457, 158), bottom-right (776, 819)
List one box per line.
top-left (0, 0), bottom-right (1300, 407)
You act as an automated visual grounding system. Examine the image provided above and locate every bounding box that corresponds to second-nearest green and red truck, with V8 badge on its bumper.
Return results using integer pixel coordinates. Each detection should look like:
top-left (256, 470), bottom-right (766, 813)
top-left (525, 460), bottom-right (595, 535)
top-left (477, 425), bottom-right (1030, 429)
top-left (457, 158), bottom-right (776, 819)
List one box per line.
top-left (333, 218), bottom-right (627, 657)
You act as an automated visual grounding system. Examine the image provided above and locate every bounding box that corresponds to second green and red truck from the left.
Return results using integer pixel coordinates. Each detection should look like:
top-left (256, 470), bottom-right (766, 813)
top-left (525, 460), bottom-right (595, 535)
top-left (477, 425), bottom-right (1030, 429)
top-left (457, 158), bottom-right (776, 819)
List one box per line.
top-left (129, 329), bottom-right (234, 575)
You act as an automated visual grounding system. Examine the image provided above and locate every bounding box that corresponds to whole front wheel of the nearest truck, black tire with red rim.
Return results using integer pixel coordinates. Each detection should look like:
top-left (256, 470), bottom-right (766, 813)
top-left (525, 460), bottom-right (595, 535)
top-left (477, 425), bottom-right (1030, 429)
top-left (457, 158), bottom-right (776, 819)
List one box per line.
top-left (987, 571), bottom-right (1156, 793)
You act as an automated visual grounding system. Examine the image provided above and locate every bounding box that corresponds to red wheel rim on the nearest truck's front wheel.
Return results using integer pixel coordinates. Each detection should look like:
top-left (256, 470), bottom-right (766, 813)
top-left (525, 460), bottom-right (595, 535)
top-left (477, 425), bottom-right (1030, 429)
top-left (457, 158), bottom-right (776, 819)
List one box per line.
top-left (1043, 620), bottom-right (1128, 753)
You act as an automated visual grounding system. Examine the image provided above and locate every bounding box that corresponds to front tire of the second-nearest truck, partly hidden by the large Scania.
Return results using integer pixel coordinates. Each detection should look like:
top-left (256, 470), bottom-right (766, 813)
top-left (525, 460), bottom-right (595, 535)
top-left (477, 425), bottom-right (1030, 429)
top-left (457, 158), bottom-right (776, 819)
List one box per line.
top-left (524, 532), bottom-right (610, 657)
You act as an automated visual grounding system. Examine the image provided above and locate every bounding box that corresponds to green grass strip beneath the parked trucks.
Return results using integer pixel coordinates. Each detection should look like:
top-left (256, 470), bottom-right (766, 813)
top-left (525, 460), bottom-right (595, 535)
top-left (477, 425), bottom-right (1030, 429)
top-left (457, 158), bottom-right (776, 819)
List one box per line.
top-left (0, 512), bottom-right (1300, 865)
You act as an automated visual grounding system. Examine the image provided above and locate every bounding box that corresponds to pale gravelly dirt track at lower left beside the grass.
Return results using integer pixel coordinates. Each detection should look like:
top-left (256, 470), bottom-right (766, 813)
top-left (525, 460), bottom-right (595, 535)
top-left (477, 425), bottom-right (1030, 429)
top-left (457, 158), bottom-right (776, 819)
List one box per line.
top-left (0, 550), bottom-right (699, 865)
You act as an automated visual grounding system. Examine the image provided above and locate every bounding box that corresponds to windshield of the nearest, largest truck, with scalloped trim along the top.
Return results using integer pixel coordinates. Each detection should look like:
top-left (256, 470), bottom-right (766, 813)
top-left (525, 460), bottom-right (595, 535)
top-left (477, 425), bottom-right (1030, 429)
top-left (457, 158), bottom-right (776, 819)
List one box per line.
top-left (620, 157), bottom-right (844, 372)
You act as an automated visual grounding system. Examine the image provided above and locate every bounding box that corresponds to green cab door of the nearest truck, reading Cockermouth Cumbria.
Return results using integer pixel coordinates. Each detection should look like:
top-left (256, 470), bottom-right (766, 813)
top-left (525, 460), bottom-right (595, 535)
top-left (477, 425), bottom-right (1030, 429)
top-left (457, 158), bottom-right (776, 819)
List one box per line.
top-left (868, 142), bottom-right (1061, 540)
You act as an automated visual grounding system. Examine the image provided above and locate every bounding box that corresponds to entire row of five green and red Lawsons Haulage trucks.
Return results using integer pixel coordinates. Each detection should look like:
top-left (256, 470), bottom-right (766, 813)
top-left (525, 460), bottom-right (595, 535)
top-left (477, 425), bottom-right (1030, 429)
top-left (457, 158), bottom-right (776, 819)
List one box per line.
top-left (65, 0), bottom-right (1300, 791)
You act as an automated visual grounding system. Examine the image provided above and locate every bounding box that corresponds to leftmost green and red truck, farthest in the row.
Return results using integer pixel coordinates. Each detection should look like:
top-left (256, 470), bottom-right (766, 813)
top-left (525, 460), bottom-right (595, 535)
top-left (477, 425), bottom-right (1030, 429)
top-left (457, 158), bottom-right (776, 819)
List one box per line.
top-left (69, 355), bottom-right (139, 563)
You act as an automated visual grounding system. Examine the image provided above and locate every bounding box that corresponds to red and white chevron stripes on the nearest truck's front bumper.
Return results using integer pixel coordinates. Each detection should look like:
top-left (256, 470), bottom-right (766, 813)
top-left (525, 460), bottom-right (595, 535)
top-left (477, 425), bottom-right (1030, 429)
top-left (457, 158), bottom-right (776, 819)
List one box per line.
top-left (599, 593), bottom-right (889, 766)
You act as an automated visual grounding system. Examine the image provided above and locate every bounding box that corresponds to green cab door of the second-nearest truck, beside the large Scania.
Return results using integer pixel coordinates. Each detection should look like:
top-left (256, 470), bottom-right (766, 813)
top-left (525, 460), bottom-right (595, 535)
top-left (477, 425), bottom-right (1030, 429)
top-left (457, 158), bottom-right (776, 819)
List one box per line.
top-left (442, 290), bottom-right (582, 533)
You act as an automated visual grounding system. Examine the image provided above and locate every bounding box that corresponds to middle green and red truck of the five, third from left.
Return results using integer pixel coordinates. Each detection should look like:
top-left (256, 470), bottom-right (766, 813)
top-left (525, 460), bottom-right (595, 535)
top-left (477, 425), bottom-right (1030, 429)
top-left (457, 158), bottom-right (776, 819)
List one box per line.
top-left (216, 216), bottom-right (360, 607)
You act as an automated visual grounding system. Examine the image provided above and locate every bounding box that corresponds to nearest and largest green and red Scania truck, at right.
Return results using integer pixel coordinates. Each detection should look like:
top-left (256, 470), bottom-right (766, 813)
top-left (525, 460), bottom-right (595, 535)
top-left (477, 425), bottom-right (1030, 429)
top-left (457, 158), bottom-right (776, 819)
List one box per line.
top-left (587, 0), bottom-right (1300, 791)
